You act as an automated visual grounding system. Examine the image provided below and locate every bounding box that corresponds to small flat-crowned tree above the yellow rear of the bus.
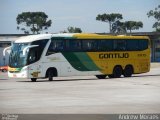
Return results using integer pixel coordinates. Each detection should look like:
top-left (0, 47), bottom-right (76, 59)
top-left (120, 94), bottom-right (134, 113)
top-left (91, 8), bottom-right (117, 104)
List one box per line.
top-left (124, 21), bottom-right (143, 33)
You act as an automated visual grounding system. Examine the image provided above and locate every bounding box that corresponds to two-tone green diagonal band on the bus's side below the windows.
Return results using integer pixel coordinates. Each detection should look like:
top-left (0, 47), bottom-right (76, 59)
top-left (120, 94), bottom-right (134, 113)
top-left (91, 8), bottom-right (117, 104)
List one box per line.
top-left (62, 52), bottom-right (99, 71)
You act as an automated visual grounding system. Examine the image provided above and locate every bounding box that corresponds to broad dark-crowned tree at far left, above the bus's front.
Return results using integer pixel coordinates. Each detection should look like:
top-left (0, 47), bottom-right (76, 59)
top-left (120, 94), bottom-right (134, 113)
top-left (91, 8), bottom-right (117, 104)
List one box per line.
top-left (16, 12), bottom-right (52, 34)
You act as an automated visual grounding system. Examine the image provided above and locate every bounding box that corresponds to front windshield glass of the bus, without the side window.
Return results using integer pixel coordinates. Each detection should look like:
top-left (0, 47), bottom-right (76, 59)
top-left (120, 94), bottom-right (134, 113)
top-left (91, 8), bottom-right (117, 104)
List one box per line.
top-left (9, 43), bottom-right (30, 68)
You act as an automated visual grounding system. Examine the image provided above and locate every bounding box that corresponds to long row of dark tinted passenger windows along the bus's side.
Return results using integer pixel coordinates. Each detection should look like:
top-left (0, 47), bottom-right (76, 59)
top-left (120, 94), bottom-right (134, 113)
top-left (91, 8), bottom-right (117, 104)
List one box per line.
top-left (47, 38), bottom-right (148, 55)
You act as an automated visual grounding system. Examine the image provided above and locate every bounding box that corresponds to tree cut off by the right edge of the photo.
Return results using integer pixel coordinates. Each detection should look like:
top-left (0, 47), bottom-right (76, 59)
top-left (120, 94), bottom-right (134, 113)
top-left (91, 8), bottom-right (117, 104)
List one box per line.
top-left (147, 5), bottom-right (160, 31)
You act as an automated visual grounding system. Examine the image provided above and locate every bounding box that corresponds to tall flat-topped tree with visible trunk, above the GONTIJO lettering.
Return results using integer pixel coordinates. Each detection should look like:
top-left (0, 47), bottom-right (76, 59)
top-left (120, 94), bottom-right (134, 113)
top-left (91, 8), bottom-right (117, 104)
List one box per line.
top-left (96, 13), bottom-right (123, 33)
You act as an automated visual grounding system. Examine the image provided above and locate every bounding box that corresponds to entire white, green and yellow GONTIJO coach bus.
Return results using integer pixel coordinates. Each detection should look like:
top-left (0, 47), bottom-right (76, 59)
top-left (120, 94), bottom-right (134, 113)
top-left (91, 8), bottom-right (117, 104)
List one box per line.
top-left (8, 33), bottom-right (150, 81)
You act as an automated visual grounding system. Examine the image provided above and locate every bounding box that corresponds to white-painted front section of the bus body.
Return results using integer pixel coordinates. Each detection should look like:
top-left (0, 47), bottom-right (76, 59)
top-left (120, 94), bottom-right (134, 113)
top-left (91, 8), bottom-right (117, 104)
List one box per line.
top-left (8, 34), bottom-right (102, 81)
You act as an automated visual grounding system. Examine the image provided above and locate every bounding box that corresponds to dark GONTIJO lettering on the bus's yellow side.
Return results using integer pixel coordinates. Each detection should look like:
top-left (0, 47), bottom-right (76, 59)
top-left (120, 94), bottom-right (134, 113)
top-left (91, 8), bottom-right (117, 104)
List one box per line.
top-left (99, 53), bottom-right (129, 59)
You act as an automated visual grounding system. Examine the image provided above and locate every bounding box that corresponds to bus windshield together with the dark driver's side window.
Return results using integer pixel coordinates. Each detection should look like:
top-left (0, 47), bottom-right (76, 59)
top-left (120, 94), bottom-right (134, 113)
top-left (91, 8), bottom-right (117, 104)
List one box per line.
top-left (9, 39), bottom-right (48, 68)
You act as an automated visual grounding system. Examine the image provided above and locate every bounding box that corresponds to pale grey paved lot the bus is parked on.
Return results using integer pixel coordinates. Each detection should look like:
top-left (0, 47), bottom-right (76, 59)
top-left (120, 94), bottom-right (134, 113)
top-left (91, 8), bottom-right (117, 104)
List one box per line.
top-left (0, 64), bottom-right (160, 114)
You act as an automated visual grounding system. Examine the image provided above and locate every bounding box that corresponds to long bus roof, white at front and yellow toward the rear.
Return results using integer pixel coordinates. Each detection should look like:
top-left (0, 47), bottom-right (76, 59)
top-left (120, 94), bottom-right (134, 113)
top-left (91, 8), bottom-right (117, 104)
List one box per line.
top-left (15, 33), bottom-right (149, 43)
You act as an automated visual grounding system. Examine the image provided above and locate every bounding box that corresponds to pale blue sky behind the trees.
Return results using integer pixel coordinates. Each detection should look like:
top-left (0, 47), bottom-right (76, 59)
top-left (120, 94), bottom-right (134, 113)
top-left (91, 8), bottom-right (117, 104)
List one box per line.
top-left (0, 0), bottom-right (160, 34)
